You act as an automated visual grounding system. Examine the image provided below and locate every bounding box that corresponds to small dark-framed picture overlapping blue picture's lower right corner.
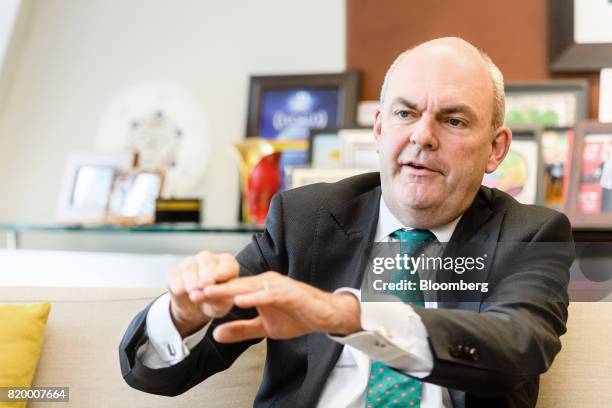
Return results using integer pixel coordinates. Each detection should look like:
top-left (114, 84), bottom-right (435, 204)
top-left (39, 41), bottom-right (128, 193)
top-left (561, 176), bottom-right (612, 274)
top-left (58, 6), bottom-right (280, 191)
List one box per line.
top-left (308, 128), bottom-right (342, 169)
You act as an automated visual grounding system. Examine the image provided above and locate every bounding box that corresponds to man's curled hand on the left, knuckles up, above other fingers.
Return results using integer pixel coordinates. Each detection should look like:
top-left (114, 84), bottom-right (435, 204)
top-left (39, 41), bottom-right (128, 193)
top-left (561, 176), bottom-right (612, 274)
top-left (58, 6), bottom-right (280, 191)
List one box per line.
top-left (168, 251), bottom-right (240, 337)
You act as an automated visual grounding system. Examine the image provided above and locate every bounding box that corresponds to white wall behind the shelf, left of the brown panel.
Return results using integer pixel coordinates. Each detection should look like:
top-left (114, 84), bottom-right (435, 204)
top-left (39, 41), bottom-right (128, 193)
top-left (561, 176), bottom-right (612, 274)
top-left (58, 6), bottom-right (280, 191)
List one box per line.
top-left (0, 0), bottom-right (345, 231)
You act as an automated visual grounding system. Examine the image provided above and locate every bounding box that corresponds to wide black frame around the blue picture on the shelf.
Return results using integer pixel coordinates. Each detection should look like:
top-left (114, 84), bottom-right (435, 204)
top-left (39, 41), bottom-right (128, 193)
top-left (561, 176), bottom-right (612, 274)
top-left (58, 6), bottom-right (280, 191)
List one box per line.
top-left (246, 71), bottom-right (359, 139)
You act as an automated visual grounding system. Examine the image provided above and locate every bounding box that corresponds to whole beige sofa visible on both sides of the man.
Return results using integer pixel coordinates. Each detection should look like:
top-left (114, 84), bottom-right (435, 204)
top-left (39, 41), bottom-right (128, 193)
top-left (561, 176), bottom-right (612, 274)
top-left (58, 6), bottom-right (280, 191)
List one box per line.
top-left (0, 287), bottom-right (612, 408)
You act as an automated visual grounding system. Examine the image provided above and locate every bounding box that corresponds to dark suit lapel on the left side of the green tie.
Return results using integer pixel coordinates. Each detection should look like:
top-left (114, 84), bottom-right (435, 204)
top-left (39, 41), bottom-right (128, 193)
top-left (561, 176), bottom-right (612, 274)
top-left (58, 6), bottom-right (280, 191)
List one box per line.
top-left (297, 187), bottom-right (380, 407)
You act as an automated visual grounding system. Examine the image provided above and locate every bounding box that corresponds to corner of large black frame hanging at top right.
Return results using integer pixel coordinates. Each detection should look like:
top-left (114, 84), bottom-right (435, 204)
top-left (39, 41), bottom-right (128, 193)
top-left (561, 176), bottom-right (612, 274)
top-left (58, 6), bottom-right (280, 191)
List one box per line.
top-left (548, 0), bottom-right (612, 72)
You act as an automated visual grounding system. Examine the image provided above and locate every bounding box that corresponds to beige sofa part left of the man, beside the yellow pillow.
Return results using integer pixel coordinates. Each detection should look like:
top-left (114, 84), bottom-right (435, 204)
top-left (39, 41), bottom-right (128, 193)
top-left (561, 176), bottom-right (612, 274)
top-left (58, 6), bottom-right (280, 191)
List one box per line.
top-left (0, 287), bottom-right (265, 408)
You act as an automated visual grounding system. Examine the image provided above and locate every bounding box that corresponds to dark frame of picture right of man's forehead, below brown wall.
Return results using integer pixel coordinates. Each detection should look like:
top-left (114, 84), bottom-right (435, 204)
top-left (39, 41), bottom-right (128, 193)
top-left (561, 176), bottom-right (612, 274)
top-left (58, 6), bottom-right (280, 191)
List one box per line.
top-left (504, 79), bottom-right (589, 128)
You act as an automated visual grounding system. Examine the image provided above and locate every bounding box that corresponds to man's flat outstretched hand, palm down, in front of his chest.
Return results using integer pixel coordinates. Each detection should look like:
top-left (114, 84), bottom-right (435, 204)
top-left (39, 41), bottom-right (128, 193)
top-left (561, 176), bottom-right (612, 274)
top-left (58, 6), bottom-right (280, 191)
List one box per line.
top-left (204, 272), bottom-right (361, 343)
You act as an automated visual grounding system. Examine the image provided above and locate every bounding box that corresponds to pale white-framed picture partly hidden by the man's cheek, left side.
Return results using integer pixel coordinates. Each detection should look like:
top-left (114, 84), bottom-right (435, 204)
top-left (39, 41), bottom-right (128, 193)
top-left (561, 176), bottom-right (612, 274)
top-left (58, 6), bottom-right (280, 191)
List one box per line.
top-left (338, 128), bottom-right (379, 171)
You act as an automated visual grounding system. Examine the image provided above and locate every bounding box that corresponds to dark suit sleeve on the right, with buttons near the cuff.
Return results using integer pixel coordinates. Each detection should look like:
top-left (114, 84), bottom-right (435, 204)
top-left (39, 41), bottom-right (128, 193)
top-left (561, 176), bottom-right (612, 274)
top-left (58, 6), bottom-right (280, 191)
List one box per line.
top-left (416, 213), bottom-right (574, 396)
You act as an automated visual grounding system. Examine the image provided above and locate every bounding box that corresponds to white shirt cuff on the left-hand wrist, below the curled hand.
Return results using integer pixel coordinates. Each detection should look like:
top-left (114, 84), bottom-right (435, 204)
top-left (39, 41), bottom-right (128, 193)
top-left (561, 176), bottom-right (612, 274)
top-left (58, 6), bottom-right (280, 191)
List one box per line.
top-left (137, 293), bottom-right (208, 368)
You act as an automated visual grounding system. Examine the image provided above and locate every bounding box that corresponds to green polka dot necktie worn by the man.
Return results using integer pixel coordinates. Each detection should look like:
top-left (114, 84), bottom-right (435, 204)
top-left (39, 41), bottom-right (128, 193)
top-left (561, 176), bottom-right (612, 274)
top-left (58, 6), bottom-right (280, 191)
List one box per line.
top-left (366, 229), bottom-right (436, 408)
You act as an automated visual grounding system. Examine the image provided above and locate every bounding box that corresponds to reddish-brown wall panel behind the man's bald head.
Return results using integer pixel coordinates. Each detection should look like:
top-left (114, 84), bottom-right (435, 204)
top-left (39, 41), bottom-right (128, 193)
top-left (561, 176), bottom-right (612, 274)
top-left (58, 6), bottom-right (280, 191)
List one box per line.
top-left (346, 0), bottom-right (599, 118)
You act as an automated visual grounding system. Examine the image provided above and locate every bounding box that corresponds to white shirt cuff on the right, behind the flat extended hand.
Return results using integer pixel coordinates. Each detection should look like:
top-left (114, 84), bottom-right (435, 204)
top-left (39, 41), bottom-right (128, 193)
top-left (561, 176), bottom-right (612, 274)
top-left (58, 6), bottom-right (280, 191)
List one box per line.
top-left (329, 288), bottom-right (433, 378)
